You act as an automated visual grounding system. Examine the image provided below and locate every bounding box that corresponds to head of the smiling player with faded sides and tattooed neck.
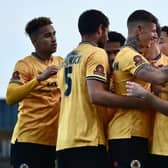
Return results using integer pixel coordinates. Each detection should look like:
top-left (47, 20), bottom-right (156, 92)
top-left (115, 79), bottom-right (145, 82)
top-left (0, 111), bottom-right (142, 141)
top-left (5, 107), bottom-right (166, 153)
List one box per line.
top-left (127, 10), bottom-right (159, 48)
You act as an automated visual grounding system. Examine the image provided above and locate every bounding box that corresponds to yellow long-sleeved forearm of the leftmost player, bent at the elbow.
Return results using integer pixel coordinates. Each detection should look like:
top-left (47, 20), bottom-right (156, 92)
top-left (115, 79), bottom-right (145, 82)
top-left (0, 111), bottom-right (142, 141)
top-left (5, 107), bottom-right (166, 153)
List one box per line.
top-left (6, 79), bottom-right (39, 104)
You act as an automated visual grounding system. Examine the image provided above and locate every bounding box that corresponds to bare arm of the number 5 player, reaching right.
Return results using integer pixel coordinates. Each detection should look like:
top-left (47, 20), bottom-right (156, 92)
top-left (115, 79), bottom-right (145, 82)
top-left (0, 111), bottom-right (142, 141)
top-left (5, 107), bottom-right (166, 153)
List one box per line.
top-left (87, 80), bottom-right (145, 109)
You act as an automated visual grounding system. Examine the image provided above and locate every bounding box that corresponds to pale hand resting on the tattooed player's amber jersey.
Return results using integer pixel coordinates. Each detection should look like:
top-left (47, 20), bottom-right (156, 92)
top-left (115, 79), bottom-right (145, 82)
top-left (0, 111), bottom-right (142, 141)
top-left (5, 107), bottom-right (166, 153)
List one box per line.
top-left (126, 81), bottom-right (148, 98)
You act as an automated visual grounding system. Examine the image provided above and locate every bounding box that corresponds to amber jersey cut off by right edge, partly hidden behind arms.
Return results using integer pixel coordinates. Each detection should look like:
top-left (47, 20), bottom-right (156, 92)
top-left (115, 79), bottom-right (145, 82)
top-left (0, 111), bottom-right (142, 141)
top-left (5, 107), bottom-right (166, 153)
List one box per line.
top-left (151, 54), bottom-right (168, 156)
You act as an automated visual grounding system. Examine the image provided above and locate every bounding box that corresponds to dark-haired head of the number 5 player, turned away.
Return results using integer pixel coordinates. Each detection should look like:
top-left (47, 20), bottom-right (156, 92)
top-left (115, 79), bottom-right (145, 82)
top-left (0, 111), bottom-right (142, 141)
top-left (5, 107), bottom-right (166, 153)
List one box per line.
top-left (78, 9), bottom-right (109, 47)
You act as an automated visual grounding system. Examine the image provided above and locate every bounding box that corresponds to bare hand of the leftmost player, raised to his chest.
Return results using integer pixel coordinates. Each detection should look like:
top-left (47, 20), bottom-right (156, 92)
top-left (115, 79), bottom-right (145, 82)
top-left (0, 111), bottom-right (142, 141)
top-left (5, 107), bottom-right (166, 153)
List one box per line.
top-left (37, 65), bottom-right (58, 81)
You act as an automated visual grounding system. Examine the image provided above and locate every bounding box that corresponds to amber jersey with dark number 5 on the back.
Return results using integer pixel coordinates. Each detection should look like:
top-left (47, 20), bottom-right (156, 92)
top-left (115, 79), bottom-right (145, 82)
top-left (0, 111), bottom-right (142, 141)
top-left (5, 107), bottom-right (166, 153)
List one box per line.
top-left (56, 43), bottom-right (108, 150)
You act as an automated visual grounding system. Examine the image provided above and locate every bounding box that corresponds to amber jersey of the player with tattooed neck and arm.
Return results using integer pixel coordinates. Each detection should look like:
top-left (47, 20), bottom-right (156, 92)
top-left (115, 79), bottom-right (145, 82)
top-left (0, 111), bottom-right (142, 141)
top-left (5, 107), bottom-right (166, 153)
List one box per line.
top-left (108, 47), bottom-right (150, 139)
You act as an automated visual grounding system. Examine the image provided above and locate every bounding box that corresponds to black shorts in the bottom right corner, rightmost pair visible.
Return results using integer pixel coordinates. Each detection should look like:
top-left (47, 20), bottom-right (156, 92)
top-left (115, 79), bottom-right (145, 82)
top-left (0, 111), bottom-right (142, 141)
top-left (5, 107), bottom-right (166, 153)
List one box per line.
top-left (148, 154), bottom-right (168, 168)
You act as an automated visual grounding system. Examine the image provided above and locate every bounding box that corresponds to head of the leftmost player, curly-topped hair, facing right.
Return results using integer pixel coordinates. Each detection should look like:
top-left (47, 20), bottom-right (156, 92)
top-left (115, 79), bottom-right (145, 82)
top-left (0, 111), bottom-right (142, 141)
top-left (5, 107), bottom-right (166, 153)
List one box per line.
top-left (25, 17), bottom-right (57, 54)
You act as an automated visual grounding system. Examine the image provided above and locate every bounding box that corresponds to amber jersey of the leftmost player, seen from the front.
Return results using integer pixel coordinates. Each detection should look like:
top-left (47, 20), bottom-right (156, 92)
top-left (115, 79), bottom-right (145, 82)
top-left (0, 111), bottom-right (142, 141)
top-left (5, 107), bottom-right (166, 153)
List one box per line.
top-left (9, 55), bottom-right (62, 146)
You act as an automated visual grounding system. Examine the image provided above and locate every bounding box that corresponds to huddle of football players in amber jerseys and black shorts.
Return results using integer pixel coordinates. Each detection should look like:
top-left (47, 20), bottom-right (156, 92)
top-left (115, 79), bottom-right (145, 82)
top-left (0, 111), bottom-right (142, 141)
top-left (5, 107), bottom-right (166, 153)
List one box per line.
top-left (6, 10), bottom-right (168, 168)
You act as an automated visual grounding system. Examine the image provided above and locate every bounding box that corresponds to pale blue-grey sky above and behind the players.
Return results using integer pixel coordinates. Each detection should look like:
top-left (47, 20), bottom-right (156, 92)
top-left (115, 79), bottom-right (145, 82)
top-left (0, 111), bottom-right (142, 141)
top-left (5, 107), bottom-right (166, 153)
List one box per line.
top-left (0, 0), bottom-right (168, 98)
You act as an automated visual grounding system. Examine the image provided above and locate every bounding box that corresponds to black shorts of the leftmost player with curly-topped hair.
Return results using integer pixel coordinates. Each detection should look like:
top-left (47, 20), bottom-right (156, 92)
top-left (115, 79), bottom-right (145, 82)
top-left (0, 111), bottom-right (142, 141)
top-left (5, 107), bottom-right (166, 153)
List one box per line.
top-left (11, 142), bottom-right (56, 168)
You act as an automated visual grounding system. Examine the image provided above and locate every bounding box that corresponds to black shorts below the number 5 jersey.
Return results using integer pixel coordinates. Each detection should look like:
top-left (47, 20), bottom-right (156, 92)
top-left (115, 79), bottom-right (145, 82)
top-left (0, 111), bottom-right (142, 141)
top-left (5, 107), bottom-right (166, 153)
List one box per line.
top-left (57, 145), bottom-right (108, 168)
